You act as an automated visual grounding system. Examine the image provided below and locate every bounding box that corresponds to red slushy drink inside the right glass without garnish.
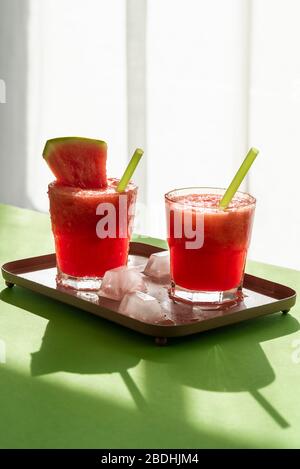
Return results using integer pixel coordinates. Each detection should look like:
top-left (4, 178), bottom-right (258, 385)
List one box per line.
top-left (167, 194), bottom-right (255, 292)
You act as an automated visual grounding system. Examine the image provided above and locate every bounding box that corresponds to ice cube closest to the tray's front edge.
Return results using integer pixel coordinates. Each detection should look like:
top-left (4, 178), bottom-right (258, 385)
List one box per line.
top-left (119, 291), bottom-right (166, 323)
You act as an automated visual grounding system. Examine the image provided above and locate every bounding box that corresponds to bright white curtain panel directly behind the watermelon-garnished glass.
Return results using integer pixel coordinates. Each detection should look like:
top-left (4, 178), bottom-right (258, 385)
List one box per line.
top-left (27, 0), bottom-right (127, 210)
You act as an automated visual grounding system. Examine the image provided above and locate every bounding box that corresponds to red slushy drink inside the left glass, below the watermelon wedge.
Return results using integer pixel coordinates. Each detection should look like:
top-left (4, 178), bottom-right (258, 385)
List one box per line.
top-left (48, 179), bottom-right (137, 277)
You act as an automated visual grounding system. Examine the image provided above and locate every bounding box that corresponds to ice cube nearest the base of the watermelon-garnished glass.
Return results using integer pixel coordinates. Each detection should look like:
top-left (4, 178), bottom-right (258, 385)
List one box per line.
top-left (98, 266), bottom-right (147, 301)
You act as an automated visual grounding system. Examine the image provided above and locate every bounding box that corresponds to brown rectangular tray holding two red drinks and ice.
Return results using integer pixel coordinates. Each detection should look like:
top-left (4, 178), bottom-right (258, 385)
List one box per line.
top-left (2, 242), bottom-right (296, 345)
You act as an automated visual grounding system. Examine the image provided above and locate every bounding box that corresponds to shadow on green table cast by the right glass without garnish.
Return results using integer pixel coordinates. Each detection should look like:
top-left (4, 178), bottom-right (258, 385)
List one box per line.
top-left (155, 313), bottom-right (299, 428)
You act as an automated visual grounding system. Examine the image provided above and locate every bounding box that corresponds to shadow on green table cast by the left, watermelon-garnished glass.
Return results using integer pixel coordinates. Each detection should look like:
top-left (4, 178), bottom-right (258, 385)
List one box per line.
top-left (0, 286), bottom-right (151, 408)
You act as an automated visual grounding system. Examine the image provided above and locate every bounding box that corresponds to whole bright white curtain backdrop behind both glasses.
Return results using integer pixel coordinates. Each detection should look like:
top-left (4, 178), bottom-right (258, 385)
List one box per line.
top-left (0, 0), bottom-right (300, 269)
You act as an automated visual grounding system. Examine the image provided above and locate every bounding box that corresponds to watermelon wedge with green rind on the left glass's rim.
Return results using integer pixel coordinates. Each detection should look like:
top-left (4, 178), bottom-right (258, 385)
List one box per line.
top-left (43, 137), bottom-right (107, 189)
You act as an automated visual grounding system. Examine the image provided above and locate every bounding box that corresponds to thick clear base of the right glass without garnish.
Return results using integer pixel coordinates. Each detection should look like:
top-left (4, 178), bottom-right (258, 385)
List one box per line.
top-left (169, 282), bottom-right (243, 309)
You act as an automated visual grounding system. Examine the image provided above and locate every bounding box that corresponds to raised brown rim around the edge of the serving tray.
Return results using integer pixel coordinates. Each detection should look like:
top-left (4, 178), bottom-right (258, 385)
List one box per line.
top-left (1, 241), bottom-right (297, 338)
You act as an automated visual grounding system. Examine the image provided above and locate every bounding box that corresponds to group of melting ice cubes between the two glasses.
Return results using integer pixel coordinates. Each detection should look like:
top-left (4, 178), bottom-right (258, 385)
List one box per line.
top-left (98, 251), bottom-right (170, 323)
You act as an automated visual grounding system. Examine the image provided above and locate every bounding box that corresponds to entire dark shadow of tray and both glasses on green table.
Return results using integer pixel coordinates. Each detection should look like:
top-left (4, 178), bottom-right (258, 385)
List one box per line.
top-left (0, 287), bottom-right (299, 428)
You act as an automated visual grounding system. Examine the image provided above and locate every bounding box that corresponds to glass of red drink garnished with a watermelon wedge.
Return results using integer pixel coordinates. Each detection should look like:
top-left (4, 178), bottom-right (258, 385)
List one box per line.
top-left (43, 137), bottom-right (137, 290)
